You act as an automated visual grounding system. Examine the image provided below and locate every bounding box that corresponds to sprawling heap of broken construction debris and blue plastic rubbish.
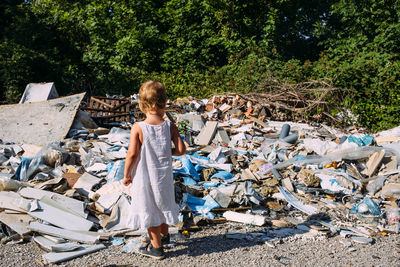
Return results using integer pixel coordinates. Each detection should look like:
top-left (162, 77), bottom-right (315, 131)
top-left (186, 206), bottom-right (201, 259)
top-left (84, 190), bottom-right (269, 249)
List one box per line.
top-left (0, 93), bottom-right (400, 263)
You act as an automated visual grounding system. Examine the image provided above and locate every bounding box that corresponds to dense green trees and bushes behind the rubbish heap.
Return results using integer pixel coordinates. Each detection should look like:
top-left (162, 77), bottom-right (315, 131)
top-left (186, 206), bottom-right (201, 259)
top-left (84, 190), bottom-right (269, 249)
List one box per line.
top-left (0, 0), bottom-right (400, 131)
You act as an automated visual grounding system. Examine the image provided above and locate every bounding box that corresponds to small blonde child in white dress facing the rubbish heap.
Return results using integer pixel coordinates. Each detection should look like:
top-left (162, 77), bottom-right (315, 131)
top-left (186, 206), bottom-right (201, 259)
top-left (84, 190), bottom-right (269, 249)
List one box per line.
top-left (122, 81), bottom-right (186, 259)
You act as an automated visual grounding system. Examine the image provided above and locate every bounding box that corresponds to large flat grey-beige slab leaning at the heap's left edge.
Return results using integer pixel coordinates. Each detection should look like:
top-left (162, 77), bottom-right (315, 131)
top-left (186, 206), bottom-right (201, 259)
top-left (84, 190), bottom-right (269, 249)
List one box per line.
top-left (0, 93), bottom-right (85, 145)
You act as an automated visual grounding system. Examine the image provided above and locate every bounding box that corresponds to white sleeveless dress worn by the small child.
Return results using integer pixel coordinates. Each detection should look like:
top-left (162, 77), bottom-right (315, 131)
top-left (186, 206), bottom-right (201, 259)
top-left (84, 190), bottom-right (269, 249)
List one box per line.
top-left (129, 121), bottom-right (179, 230)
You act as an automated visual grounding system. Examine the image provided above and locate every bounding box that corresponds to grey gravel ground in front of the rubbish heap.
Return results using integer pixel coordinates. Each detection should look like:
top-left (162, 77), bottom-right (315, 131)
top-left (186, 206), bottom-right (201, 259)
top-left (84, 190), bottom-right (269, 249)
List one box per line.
top-left (0, 224), bottom-right (400, 267)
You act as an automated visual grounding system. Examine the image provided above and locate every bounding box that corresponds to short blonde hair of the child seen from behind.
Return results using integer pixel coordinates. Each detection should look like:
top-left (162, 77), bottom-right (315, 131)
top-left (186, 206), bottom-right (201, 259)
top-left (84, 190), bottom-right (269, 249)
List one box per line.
top-left (139, 81), bottom-right (167, 113)
